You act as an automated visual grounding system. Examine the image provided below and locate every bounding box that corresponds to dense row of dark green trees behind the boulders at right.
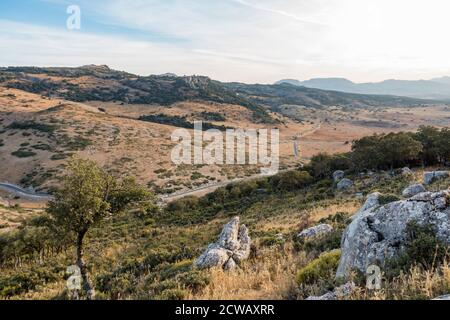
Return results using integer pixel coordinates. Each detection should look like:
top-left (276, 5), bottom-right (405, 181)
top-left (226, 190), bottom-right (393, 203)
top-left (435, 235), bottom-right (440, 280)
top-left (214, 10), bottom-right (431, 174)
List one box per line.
top-left (307, 126), bottom-right (450, 178)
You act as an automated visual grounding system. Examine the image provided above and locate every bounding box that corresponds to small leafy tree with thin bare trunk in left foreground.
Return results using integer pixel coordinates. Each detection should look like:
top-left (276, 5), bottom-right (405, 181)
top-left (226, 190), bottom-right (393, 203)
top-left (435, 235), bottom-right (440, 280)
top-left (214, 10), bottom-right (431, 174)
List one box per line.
top-left (47, 158), bottom-right (153, 299)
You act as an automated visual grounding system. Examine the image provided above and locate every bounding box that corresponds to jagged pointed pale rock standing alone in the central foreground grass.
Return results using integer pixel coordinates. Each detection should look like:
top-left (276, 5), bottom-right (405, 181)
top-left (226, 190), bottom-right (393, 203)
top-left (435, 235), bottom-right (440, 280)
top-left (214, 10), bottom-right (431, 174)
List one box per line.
top-left (194, 217), bottom-right (251, 271)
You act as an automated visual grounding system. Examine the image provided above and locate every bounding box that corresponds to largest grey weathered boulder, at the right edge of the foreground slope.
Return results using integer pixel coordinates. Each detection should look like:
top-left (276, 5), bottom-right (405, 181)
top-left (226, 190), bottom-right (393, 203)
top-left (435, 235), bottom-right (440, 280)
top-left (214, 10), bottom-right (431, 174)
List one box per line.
top-left (336, 190), bottom-right (450, 278)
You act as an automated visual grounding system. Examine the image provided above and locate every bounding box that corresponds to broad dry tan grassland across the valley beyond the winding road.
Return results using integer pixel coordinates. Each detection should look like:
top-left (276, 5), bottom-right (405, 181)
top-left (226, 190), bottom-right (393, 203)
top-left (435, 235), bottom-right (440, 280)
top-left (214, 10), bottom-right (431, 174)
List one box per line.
top-left (0, 84), bottom-right (450, 193)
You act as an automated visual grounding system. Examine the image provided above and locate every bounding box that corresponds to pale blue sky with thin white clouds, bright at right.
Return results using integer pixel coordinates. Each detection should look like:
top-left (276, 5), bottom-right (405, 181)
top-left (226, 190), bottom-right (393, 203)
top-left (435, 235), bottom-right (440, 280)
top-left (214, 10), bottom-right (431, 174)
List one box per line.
top-left (0, 0), bottom-right (450, 83)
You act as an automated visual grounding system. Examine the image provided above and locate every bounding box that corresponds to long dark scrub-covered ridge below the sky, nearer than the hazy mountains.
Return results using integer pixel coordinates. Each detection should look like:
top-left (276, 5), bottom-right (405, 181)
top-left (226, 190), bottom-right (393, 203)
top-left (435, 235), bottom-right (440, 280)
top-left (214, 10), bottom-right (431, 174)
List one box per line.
top-left (0, 65), bottom-right (434, 123)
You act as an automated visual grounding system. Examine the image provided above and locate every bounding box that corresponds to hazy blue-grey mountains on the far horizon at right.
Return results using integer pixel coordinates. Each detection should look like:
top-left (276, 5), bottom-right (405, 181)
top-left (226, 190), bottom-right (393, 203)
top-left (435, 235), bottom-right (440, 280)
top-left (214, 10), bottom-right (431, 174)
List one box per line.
top-left (277, 77), bottom-right (450, 100)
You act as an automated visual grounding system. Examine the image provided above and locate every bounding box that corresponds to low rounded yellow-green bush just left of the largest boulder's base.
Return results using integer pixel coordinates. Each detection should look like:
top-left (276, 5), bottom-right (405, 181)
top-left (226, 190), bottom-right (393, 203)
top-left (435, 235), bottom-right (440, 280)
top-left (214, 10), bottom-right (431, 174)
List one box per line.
top-left (297, 250), bottom-right (341, 285)
